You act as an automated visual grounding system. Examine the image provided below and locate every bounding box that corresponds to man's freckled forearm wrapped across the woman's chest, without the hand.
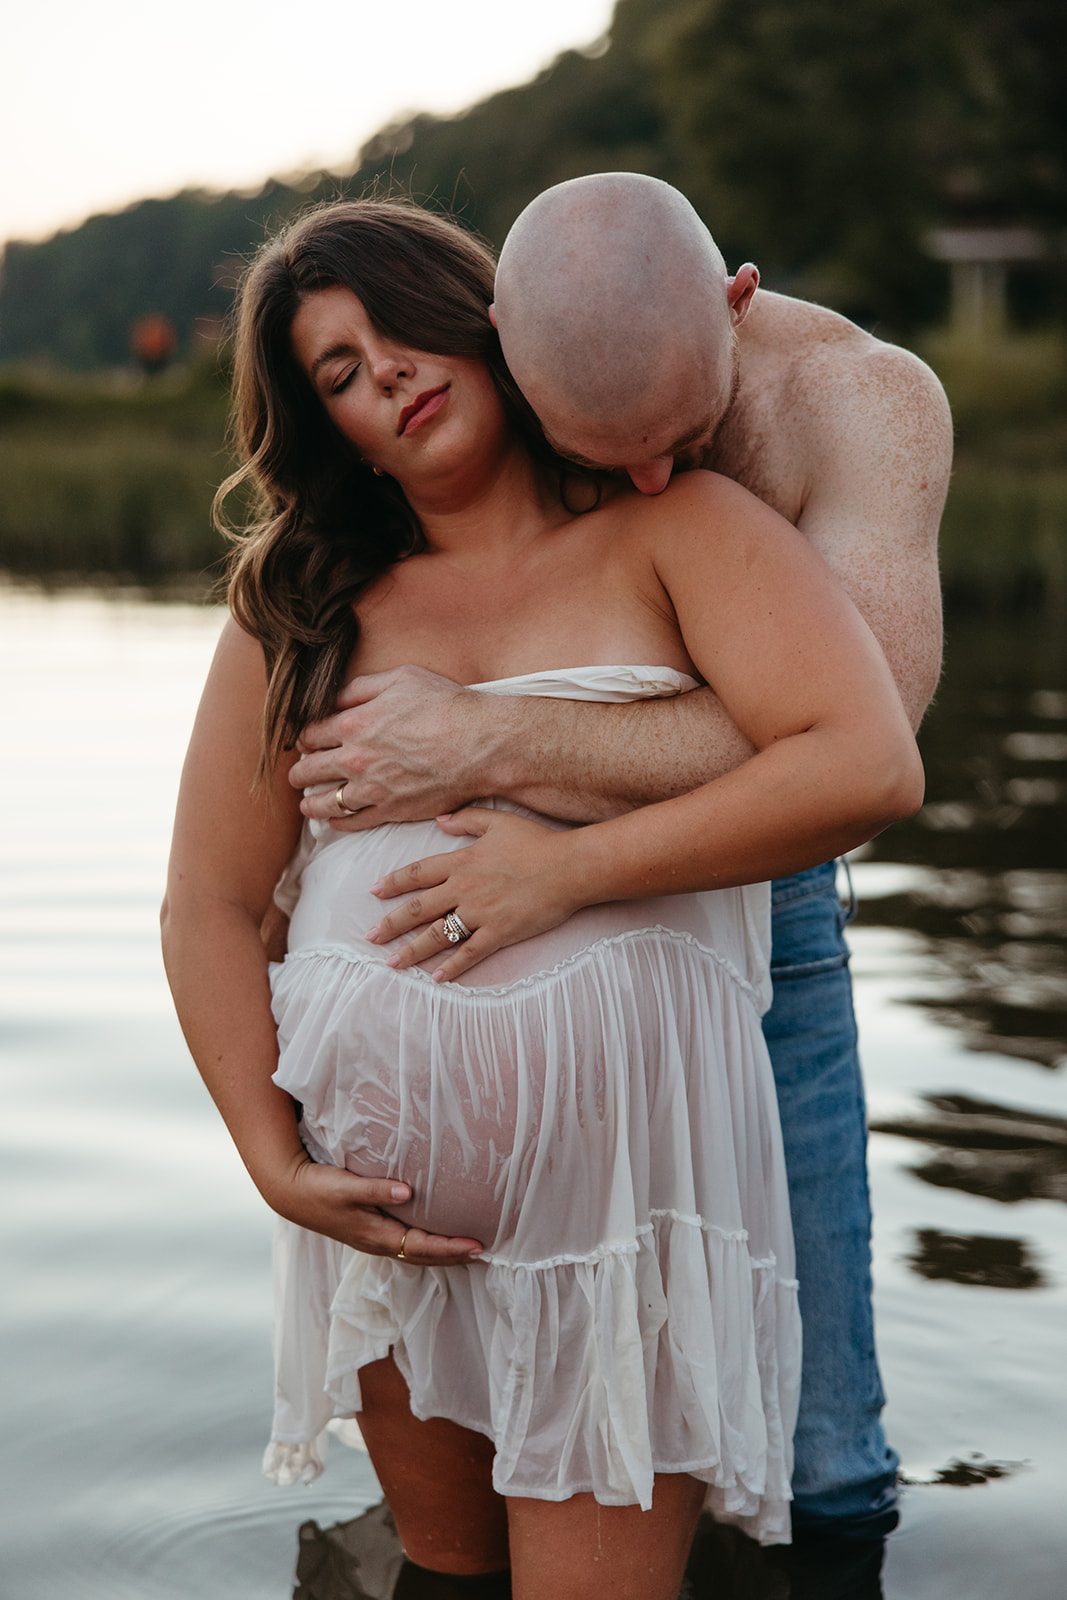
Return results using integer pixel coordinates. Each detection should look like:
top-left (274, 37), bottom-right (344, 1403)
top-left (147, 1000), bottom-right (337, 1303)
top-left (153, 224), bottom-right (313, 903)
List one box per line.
top-left (472, 690), bottom-right (755, 822)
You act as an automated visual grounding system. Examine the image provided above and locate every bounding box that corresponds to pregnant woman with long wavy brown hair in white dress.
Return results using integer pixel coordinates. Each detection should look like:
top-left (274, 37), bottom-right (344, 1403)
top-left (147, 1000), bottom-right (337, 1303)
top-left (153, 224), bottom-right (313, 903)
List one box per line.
top-left (163, 202), bottom-right (921, 1600)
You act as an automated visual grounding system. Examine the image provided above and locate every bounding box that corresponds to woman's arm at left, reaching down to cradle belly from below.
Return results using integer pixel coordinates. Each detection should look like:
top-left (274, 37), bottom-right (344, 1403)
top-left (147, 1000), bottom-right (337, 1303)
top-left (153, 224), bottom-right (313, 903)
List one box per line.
top-left (162, 622), bottom-right (478, 1262)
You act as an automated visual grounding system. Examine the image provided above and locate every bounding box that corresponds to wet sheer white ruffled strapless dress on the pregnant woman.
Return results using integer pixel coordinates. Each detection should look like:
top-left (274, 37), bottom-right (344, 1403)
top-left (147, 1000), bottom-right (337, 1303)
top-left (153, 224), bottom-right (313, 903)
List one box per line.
top-left (264, 667), bottom-right (800, 1542)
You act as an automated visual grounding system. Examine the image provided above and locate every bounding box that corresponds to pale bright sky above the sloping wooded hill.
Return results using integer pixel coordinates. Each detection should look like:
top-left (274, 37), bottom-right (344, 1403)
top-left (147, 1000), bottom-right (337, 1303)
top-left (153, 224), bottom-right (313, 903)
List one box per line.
top-left (0, 0), bottom-right (613, 243)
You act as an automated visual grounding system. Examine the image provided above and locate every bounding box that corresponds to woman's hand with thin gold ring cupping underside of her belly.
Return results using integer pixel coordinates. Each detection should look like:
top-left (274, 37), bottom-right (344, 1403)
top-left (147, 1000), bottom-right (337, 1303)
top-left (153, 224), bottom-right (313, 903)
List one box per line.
top-left (264, 1160), bottom-right (482, 1267)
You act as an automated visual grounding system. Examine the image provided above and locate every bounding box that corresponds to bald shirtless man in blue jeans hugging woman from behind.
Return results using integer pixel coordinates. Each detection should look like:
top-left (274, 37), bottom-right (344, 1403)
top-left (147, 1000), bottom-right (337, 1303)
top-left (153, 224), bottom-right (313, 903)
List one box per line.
top-left (291, 173), bottom-right (952, 1539)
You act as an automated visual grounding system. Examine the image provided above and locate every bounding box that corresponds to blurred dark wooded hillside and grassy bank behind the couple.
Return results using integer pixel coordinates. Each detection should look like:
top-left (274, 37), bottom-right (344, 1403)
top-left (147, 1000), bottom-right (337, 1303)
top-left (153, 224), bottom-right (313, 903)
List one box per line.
top-left (0, 0), bottom-right (1067, 595)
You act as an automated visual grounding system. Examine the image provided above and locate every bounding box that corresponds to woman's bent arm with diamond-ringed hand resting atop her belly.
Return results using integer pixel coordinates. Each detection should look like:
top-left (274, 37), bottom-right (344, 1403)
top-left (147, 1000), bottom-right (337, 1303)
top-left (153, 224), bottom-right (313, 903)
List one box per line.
top-left (367, 474), bottom-right (923, 978)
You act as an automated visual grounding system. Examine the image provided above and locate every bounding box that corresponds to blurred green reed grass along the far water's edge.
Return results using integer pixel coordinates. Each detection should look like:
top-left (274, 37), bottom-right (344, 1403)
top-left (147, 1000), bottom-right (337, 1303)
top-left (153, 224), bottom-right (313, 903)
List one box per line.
top-left (0, 334), bottom-right (1067, 610)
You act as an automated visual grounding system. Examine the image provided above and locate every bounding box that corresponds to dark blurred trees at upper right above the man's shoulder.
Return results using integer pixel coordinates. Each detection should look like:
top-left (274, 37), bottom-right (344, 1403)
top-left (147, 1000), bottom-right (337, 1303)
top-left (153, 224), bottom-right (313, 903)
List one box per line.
top-left (643, 0), bottom-right (1067, 331)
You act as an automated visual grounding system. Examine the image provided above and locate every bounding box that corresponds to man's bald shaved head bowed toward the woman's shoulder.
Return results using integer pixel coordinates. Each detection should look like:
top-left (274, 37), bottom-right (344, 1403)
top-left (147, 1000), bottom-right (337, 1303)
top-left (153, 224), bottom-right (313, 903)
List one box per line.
top-left (496, 173), bottom-right (751, 488)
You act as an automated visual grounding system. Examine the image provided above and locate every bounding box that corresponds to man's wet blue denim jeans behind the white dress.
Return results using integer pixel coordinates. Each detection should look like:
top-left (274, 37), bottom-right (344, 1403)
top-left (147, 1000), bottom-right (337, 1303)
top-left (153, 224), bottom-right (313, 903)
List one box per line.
top-left (763, 861), bottom-right (897, 1533)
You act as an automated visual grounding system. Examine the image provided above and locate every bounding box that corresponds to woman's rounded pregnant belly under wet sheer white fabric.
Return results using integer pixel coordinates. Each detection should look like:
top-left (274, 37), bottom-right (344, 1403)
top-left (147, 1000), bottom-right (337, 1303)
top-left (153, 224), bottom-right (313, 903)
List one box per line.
top-left (272, 824), bottom-right (765, 1250)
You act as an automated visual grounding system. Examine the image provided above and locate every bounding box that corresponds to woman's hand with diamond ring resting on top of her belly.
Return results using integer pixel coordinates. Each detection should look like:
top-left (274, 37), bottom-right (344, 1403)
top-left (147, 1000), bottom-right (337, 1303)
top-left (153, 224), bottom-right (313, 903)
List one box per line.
top-left (366, 806), bottom-right (584, 982)
